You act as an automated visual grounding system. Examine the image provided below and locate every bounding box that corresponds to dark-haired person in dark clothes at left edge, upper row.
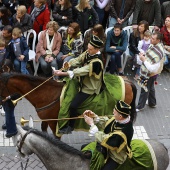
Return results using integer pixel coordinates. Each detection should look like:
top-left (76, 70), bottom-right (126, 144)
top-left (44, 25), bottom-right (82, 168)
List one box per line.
top-left (0, 6), bottom-right (11, 30)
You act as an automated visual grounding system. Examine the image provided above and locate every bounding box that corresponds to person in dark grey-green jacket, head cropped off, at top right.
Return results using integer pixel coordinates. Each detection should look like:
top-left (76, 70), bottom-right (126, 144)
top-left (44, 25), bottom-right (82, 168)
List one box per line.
top-left (132, 0), bottom-right (161, 30)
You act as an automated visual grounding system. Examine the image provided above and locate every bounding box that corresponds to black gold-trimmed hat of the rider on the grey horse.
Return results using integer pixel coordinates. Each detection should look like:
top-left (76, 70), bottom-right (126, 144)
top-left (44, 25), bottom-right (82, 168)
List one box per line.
top-left (115, 100), bottom-right (131, 116)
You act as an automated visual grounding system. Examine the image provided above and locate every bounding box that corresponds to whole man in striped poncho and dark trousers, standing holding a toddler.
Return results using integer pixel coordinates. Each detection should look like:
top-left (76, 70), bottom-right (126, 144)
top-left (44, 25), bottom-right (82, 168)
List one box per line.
top-left (136, 31), bottom-right (164, 112)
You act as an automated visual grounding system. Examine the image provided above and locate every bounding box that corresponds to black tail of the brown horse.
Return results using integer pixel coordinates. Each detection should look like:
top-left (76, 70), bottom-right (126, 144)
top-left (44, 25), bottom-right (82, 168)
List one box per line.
top-left (130, 82), bottom-right (137, 123)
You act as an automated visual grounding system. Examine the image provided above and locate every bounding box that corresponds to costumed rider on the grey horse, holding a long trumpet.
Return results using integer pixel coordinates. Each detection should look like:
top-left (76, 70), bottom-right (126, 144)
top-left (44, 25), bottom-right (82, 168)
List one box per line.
top-left (82, 100), bottom-right (134, 170)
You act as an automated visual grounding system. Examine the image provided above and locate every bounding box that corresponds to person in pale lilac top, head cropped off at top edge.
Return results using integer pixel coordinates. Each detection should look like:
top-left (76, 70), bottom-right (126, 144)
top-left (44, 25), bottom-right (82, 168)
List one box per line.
top-left (94, 0), bottom-right (110, 24)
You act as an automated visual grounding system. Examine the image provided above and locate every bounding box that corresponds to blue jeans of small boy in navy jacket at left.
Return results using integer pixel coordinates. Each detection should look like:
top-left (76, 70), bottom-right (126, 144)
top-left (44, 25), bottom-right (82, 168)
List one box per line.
top-left (14, 58), bottom-right (29, 74)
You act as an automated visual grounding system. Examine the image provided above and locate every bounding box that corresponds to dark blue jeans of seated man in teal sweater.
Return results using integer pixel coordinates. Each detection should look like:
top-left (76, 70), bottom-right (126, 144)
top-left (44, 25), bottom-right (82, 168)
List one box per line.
top-left (110, 52), bottom-right (122, 74)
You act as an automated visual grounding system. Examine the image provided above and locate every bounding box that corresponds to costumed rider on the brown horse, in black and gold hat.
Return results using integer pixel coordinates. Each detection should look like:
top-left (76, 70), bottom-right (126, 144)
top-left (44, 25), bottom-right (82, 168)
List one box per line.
top-left (54, 36), bottom-right (103, 134)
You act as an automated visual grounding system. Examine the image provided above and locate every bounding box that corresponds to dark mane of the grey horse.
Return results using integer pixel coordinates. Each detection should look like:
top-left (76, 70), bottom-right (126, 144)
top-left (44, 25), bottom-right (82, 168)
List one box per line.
top-left (23, 126), bottom-right (86, 159)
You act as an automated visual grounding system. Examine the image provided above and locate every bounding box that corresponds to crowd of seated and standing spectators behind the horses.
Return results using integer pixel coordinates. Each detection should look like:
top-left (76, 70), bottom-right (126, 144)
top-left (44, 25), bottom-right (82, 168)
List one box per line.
top-left (0, 0), bottom-right (170, 77)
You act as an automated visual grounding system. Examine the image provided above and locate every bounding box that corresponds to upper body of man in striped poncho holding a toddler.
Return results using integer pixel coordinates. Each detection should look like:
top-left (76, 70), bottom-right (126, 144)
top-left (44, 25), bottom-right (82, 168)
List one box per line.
top-left (138, 31), bottom-right (165, 92)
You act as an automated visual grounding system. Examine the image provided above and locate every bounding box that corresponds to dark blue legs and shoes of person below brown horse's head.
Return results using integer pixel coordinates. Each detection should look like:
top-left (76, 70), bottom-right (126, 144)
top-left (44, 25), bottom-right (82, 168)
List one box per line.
top-left (2, 94), bottom-right (20, 138)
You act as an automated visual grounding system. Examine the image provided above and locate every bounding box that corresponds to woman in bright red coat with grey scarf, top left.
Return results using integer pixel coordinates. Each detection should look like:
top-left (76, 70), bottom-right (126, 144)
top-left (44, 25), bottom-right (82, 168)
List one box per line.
top-left (28, 0), bottom-right (50, 34)
